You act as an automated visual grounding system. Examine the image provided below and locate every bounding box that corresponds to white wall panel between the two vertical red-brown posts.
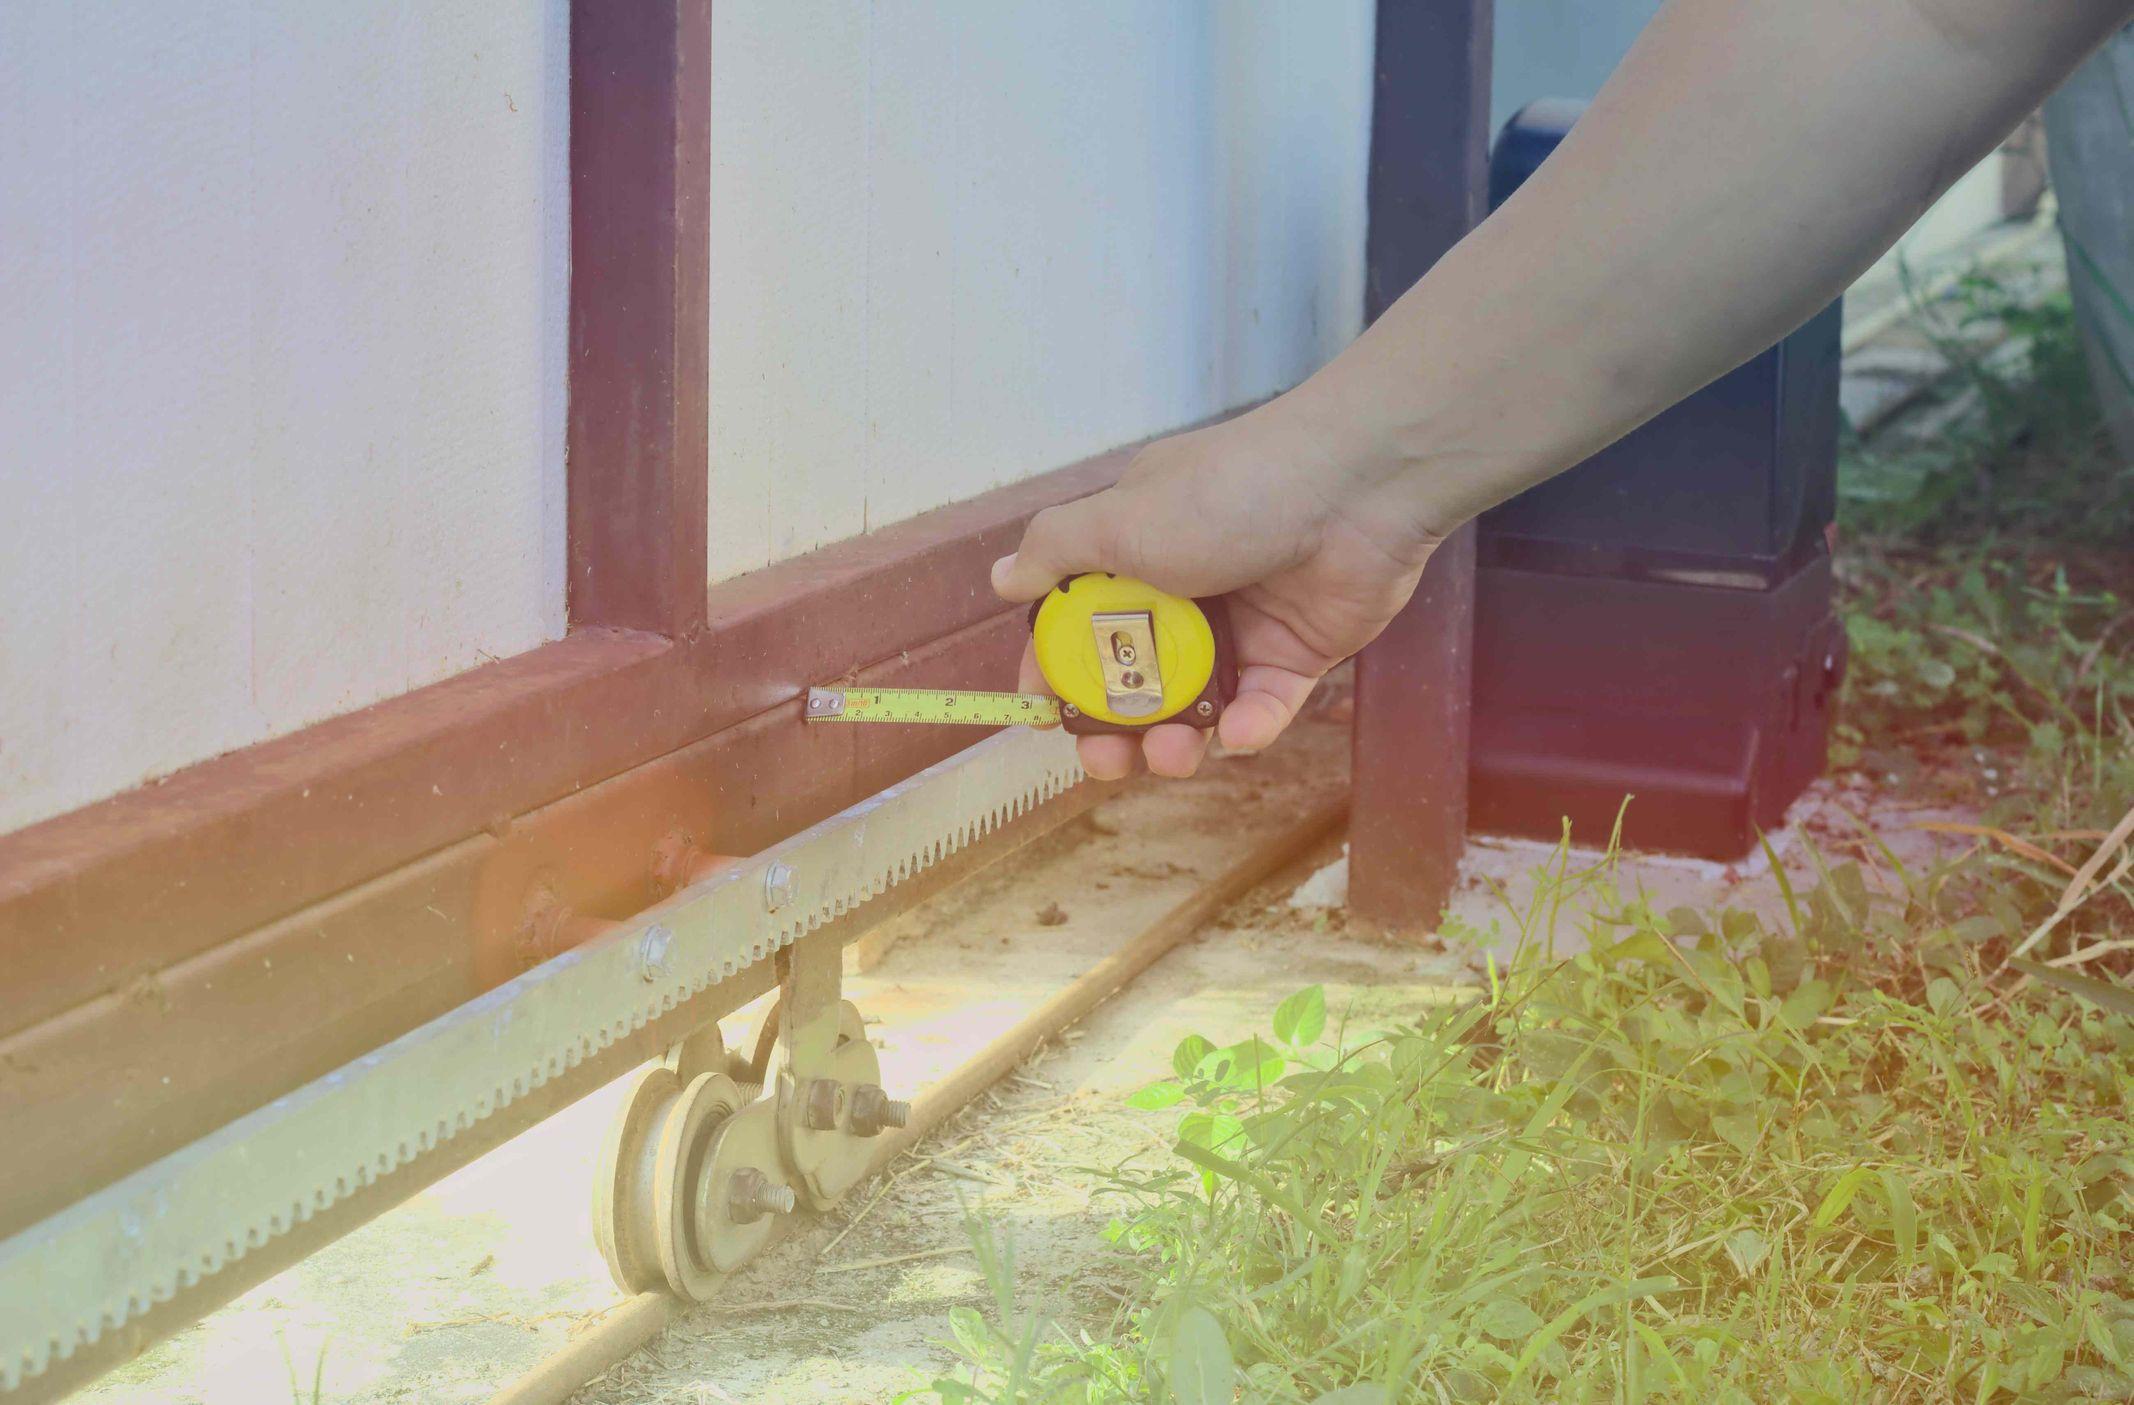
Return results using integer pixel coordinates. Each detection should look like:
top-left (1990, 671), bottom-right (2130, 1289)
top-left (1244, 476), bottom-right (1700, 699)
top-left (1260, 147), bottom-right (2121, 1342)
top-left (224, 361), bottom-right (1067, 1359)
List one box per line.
top-left (711, 0), bottom-right (1372, 579)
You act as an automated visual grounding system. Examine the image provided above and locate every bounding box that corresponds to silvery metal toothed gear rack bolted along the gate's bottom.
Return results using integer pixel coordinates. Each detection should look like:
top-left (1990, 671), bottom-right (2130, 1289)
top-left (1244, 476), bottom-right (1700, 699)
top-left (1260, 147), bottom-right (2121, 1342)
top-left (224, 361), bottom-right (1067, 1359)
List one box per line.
top-left (0, 730), bottom-right (1103, 1405)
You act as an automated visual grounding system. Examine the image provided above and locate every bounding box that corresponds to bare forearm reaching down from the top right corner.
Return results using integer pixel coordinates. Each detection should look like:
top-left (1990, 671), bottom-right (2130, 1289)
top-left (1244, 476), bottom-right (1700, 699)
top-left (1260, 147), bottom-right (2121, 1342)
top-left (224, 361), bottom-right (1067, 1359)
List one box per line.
top-left (1295, 0), bottom-right (2134, 534)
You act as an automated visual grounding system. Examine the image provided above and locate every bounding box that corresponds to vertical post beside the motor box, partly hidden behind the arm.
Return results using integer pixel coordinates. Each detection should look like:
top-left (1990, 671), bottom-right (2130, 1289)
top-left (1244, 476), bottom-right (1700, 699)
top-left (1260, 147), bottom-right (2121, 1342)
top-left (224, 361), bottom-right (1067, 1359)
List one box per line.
top-left (1349, 0), bottom-right (1494, 933)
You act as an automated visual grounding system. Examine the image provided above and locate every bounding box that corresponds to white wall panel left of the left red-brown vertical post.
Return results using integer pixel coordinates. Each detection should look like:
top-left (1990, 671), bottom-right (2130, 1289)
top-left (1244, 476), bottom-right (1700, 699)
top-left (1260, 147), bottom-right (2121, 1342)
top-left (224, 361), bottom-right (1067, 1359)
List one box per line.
top-left (0, 0), bottom-right (570, 828)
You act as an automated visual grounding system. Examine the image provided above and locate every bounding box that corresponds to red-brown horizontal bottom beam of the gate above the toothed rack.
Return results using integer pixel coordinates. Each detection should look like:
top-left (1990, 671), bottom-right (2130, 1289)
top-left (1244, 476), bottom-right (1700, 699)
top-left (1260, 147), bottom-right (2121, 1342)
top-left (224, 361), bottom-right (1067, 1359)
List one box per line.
top-left (0, 437), bottom-right (1169, 1234)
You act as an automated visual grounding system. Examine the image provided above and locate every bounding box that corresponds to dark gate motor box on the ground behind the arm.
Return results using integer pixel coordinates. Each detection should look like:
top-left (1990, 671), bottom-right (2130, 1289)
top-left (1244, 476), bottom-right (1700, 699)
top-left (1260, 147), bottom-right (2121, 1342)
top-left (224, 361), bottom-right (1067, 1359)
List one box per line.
top-left (1468, 98), bottom-right (1846, 858)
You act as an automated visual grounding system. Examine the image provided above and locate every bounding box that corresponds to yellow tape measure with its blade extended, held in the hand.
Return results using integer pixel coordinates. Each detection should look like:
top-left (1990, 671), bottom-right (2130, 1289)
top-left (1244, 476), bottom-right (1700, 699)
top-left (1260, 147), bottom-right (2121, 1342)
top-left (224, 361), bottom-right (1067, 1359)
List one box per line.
top-left (805, 574), bottom-right (1238, 735)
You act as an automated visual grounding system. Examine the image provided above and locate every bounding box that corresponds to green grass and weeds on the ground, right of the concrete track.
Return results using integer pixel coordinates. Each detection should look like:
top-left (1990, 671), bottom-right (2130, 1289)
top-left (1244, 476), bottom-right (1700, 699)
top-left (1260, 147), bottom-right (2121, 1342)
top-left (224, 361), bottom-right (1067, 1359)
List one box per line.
top-left (924, 267), bottom-right (2134, 1405)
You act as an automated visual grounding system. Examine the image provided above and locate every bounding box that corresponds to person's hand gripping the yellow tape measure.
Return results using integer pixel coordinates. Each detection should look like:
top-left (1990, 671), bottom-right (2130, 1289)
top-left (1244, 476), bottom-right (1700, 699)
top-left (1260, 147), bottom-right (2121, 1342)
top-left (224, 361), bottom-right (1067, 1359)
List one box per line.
top-left (992, 393), bottom-right (1436, 779)
